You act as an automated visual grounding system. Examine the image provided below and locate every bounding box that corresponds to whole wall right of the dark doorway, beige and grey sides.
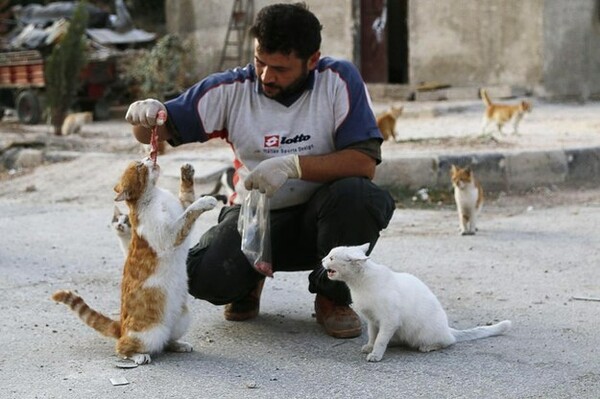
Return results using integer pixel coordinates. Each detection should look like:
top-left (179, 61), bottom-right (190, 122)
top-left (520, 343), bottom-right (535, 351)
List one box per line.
top-left (409, 0), bottom-right (600, 100)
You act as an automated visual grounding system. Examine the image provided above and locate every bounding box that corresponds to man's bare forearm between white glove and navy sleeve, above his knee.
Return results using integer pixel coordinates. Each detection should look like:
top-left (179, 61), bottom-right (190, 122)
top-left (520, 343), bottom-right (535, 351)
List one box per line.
top-left (299, 149), bottom-right (377, 183)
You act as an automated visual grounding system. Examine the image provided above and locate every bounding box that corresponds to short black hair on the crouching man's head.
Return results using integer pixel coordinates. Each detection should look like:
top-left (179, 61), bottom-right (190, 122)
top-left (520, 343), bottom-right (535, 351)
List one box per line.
top-left (250, 3), bottom-right (322, 60)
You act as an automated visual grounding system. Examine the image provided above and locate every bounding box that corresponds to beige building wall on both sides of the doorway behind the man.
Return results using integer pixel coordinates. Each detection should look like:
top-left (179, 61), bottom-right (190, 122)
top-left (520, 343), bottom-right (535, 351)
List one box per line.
top-left (165, 0), bottom-right (600, 99)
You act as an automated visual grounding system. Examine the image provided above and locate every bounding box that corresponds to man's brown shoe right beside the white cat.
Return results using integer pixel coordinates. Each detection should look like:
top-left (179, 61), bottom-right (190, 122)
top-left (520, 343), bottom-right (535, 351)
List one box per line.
top-left (315, 294), bottom-right (362, 338)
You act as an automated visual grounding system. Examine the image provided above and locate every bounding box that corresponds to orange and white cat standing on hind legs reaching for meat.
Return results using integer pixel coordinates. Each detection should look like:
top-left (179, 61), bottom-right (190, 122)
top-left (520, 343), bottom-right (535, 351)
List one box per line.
top-left (52, 158), bottom-right (217, 365)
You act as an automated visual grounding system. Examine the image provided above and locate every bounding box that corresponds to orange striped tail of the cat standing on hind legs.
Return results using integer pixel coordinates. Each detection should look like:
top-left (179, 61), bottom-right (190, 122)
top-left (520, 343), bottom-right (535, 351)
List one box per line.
top-left (52, 290), bottom-right (121, 339)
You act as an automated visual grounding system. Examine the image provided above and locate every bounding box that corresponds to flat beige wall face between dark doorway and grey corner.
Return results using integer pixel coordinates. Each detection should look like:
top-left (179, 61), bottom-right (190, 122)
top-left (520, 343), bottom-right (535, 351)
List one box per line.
top-left (408, 0), bottom-right (544, 90)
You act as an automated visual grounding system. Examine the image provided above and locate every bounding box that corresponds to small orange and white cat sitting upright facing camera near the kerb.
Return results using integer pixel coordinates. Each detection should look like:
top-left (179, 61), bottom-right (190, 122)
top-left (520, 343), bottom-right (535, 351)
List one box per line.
top-left (450, 165), bottom-right (484, 236)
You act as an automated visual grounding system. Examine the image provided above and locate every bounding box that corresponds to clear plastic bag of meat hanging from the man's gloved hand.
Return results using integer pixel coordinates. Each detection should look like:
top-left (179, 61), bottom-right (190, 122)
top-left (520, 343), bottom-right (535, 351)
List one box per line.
top-left (238, 190), bottom-right (273, 277)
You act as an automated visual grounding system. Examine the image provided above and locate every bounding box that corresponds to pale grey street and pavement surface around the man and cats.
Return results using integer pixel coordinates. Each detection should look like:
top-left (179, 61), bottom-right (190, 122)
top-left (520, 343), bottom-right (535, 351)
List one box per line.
top-left (0, 99), bottom-right (600, 398)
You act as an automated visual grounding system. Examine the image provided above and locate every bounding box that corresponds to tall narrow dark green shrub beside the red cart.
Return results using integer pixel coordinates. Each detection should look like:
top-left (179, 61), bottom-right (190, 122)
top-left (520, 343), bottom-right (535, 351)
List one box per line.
top-left (44, 1), bottom-right (88, 135)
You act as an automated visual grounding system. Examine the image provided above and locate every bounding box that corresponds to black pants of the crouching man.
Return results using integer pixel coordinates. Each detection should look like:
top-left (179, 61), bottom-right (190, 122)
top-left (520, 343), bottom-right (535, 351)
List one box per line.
top-left (187, 177), bottom-right (395, 305)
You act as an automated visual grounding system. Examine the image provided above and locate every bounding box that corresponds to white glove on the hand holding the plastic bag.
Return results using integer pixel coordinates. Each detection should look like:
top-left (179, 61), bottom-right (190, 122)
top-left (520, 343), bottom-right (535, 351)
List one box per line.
top-left (244, 154), bottom-right (302, 197)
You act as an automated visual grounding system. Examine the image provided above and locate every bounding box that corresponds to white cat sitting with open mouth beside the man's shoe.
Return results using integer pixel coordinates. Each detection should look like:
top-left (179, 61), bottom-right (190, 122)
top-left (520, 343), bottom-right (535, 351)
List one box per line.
top-left (323, 244), bottom-right (511, 362)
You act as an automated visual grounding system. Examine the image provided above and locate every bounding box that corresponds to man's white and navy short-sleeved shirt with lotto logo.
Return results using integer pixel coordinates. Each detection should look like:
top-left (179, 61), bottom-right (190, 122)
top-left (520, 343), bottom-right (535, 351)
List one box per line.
top-left (165, 57), bottom-right (381, 209)
